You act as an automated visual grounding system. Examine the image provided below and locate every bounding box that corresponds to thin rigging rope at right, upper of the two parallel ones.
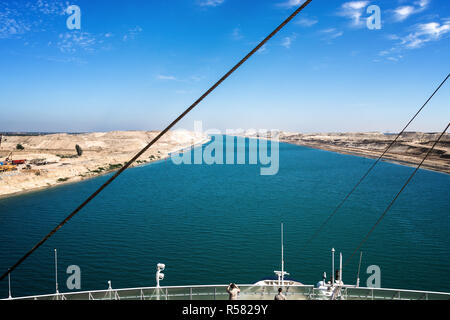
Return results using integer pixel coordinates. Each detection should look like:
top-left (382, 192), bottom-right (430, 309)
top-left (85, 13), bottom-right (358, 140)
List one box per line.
top-left (302, 74), bottom-right (450, 250)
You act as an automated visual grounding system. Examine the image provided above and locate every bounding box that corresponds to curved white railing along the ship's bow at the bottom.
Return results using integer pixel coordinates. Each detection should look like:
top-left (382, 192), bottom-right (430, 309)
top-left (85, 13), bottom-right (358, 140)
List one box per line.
top-left (5, 285), bottom-right (450, 300)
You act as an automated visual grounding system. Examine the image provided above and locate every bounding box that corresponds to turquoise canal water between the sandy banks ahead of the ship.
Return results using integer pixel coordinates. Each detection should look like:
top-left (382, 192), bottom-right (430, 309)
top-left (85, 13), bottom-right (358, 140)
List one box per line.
top-left (0, 136), bottom-right (450, 297)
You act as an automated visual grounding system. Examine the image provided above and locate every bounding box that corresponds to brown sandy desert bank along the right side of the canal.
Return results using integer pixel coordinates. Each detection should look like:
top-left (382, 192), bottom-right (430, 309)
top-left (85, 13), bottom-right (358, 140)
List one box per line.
top-left (247, 132), bottom-right (450, 174)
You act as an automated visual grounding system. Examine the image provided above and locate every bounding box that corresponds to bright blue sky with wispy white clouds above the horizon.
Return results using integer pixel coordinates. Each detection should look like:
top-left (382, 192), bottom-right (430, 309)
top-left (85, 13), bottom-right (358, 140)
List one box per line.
top-left (0, 0), bottom-right (450, 132)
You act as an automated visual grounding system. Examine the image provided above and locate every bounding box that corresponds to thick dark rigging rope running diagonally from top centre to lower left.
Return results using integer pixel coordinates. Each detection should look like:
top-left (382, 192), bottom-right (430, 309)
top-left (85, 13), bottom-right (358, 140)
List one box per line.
top-left (0, 0), bottom-right (312, 281)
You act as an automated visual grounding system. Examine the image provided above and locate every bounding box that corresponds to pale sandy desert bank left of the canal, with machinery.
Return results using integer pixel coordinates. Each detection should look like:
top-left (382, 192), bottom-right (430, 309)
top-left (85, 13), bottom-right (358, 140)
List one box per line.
top-left (0, 130), bottom-right (209, 197)
